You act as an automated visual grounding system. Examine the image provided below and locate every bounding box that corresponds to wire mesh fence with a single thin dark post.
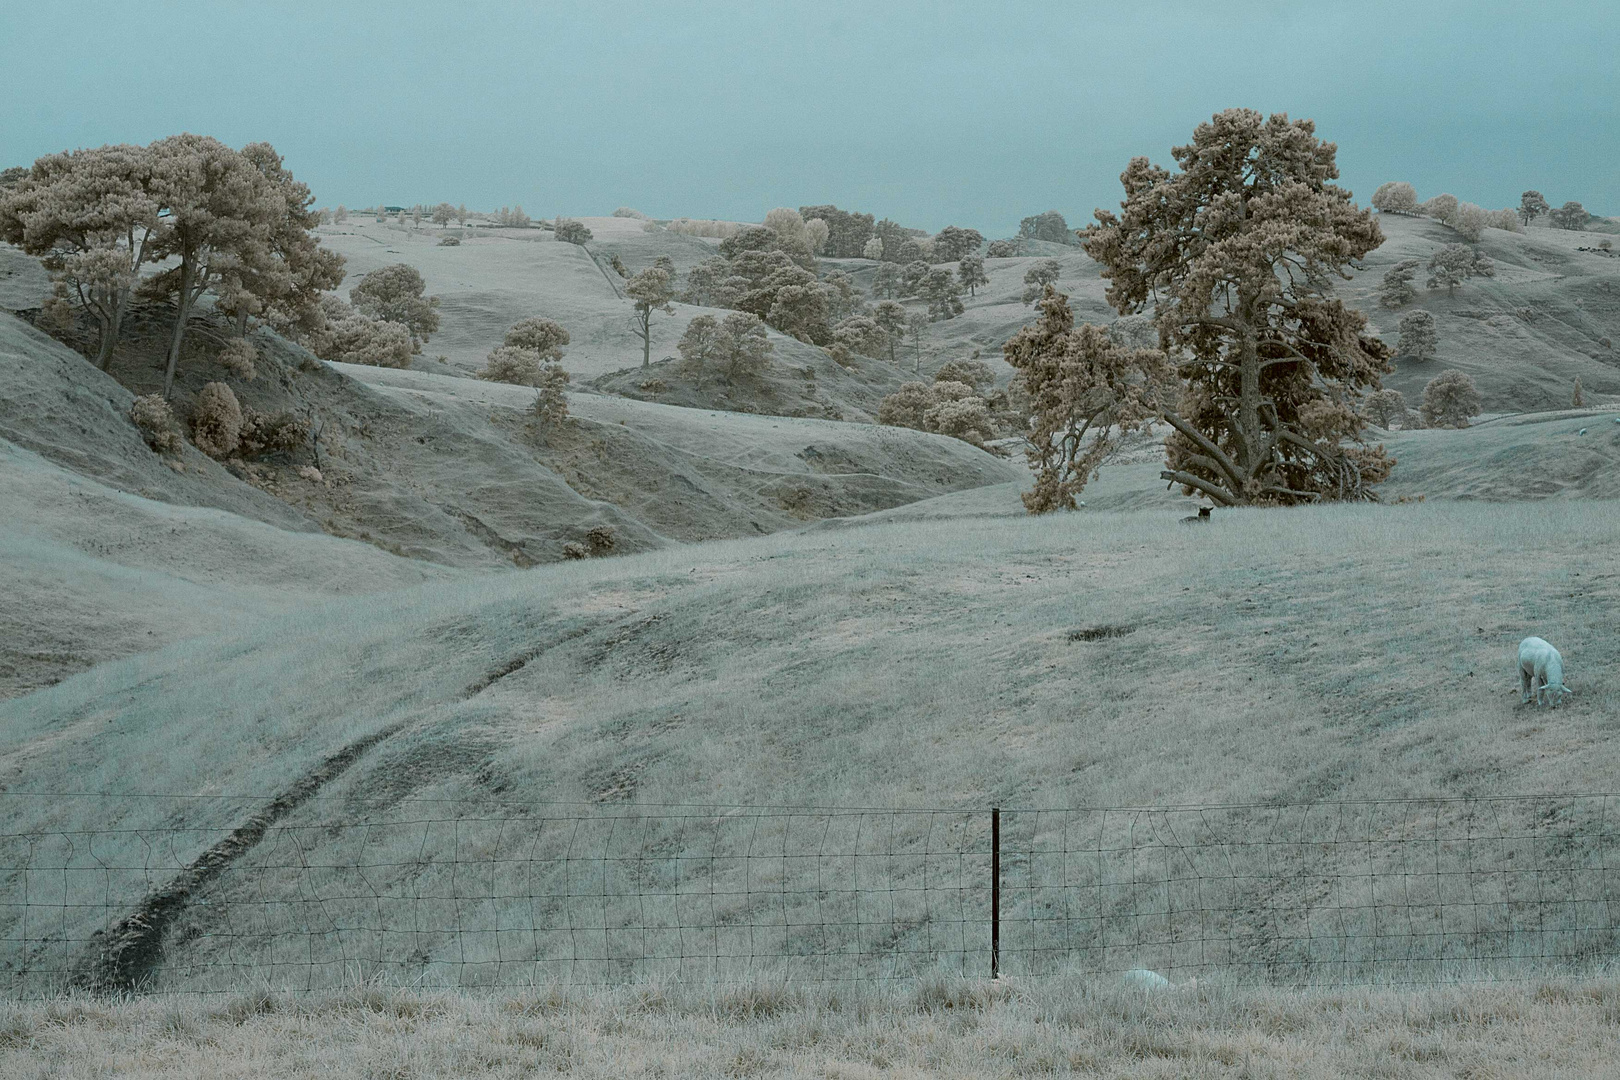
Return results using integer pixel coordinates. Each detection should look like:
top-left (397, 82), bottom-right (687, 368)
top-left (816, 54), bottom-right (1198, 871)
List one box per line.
top-left (0, 793), bottom-right (1620, 997)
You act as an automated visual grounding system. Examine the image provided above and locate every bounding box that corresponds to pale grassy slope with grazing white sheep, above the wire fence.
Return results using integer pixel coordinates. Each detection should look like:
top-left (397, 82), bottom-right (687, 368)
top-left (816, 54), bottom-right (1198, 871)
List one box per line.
top-left (0, 500), bottom-right (1620, 980)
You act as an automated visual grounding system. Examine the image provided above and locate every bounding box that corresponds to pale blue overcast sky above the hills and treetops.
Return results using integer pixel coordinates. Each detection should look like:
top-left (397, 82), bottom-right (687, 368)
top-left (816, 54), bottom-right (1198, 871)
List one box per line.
top-left (0, 0), bottom-right (1620, 235)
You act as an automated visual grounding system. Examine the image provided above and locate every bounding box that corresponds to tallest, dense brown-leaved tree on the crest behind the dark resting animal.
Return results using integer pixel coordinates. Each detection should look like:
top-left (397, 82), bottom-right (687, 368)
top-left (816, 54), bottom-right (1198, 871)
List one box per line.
top-left (1084, 108), bottom-right (1393, 505)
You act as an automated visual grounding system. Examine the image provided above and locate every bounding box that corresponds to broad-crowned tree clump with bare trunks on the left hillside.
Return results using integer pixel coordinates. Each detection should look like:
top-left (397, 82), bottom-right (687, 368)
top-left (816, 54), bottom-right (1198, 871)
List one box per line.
top-left (0, 134), bottom-right (343, 390)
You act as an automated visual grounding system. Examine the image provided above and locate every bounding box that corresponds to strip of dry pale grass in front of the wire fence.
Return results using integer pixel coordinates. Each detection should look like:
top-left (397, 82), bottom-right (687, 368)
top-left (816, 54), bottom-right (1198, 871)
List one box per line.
top-left (0, 978), bottom-right (1620, 1080)
